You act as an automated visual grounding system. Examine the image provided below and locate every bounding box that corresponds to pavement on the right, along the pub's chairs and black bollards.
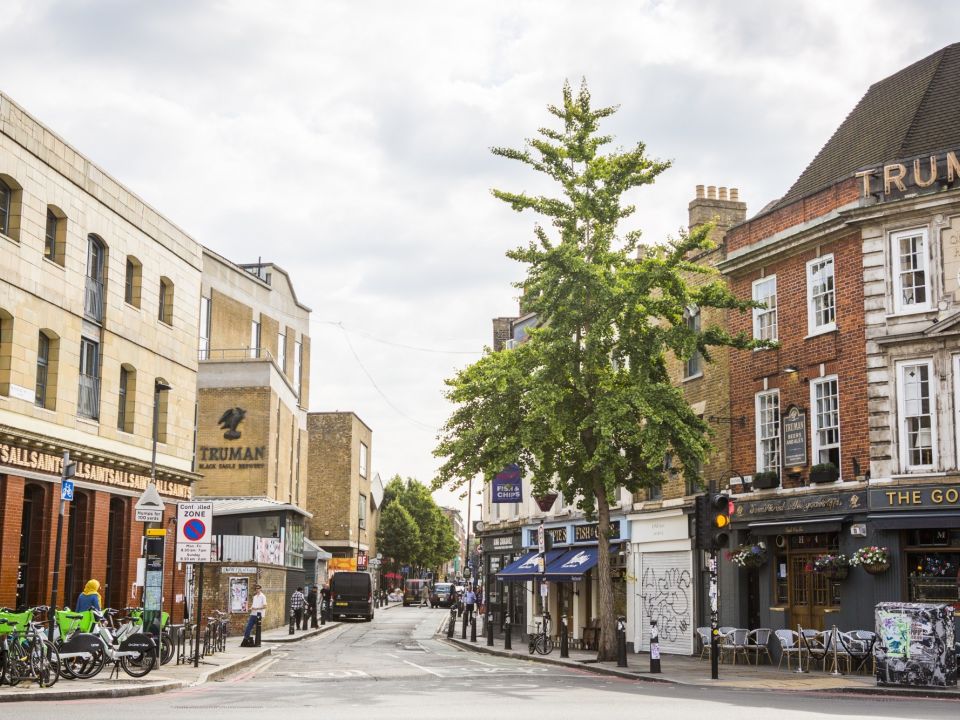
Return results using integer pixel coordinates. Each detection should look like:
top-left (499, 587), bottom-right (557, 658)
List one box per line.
top-left (441, 620), bottom-right (960, 700)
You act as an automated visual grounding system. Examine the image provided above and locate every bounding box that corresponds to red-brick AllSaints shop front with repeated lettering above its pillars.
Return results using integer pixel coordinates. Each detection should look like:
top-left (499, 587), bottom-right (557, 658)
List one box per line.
top-left (0, 431), bottom-right (196, 609)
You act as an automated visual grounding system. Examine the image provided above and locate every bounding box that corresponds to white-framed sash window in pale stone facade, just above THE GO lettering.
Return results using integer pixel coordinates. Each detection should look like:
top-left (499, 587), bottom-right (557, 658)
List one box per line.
top-left (897, 360), bottom-right (937, 470)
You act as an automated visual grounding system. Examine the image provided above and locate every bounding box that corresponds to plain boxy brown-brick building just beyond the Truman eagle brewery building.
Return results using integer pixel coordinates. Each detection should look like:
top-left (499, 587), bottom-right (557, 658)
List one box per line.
top-left (306, 412), bottom-right (383, 571)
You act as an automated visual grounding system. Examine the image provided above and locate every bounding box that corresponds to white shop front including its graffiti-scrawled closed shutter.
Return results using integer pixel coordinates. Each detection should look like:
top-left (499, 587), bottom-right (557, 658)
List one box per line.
top-left (627, 507), bottom-right (698, 655)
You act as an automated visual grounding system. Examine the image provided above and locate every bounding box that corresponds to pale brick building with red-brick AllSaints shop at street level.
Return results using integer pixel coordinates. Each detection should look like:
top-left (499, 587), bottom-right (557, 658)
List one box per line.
top-left (0, 95), bottom-right (201, 608)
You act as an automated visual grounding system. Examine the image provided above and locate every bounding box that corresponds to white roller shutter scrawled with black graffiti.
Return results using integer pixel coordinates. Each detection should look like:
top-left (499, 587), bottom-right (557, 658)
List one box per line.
top-left (637, 550), bottom-right (696, 655)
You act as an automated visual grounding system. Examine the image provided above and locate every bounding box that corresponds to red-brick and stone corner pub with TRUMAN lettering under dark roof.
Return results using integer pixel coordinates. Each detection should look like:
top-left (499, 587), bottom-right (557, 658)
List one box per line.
top-left (721, 45), bottom-right (960, 628)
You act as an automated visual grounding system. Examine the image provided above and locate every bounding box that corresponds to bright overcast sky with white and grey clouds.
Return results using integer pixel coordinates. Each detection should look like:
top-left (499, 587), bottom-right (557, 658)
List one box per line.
top-left (0, 0), bottom-right (960, 516)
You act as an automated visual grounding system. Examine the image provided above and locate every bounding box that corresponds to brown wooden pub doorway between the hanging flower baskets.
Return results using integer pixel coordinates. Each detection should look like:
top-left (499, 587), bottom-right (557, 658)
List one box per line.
top-left (776, 533), bottom-right (840, 630)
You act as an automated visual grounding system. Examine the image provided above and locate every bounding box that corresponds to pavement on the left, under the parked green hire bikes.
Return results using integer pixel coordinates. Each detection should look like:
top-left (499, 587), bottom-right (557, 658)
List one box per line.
top-left (0, 603), bottom-right (399, 703)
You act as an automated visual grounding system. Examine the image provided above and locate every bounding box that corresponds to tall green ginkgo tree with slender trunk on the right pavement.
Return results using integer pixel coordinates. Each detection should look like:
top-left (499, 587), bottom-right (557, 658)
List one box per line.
top-left (434, 82), bottom-right (755, 660)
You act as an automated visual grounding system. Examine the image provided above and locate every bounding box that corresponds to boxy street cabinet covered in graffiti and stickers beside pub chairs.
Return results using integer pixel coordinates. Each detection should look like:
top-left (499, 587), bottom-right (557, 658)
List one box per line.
top-left (873, 602), bottom-right (957, 687)
